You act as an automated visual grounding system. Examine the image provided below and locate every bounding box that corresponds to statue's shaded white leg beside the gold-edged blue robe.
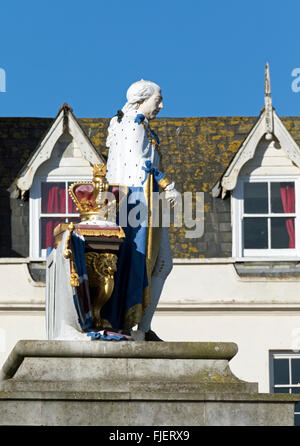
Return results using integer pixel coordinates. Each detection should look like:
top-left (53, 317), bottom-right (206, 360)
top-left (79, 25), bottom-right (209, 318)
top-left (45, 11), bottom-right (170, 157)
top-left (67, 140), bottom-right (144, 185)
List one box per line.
top-left (138, 228), bottom-right (173, 333)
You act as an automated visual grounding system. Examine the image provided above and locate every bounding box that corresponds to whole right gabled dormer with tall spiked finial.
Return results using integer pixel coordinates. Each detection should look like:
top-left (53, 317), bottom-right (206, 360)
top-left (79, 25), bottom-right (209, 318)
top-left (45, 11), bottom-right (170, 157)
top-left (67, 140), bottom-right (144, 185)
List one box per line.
top-left (216, 64), bottom-right (300, 260)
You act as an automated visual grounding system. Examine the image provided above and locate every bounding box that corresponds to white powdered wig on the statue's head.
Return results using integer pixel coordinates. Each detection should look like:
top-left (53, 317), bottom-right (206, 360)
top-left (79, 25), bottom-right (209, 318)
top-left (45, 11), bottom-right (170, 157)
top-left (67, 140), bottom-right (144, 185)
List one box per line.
top-left (106, 79), bottom-right (160, 147)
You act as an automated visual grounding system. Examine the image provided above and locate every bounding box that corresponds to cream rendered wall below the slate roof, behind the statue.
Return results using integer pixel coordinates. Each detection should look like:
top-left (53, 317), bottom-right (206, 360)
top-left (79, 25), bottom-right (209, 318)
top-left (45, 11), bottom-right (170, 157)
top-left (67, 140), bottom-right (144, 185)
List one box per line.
top-left (0, 259), bottom-right (300, 392)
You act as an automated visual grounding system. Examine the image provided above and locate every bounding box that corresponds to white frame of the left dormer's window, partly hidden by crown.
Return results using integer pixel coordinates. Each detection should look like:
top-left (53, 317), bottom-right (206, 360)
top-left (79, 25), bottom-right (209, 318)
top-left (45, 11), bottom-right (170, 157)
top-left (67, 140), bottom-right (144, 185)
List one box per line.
top-left (29, 175), bottom-right (91, 261)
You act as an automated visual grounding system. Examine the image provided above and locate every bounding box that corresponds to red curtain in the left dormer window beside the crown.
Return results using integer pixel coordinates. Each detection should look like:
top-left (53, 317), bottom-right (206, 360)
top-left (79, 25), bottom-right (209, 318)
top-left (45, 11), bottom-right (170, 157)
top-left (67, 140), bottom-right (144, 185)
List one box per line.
top-left (42, 183), bottom-right (66, 248)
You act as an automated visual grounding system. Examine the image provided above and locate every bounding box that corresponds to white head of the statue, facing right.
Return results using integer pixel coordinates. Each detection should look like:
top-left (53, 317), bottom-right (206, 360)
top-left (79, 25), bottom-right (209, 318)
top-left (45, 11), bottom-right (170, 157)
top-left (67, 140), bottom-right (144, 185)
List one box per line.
top-left (126, 79), bottom-right (163, 119)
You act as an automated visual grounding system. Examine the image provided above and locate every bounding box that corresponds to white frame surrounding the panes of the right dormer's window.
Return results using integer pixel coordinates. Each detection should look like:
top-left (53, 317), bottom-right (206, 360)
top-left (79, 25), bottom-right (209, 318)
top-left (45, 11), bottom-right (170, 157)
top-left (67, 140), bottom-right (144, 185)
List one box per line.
top-left (231, 175), bottom-right (300, 261)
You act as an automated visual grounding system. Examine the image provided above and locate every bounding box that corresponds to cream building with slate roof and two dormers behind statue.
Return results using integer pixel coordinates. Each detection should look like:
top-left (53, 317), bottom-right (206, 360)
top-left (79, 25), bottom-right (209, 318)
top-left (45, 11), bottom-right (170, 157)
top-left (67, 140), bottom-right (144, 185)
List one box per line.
top-left (0, 67), bottom-right (300, 422)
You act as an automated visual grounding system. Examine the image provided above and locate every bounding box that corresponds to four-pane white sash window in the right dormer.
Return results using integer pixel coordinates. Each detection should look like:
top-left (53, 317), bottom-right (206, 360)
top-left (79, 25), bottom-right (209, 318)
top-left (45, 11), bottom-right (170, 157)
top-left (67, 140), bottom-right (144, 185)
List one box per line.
top-left (232, 176), bottom-right (300, 258)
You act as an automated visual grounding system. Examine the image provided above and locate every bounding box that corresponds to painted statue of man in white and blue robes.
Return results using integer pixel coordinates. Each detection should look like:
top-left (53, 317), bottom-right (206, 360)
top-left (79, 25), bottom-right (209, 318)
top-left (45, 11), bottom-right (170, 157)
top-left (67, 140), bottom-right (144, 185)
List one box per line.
top-left (46, 80), bottom-right (179, 341)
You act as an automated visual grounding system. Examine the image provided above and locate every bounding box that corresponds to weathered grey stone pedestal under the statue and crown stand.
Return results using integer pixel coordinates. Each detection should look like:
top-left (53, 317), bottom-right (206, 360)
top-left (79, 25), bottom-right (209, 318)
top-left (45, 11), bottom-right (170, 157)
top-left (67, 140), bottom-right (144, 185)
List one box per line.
top-left (0, 341), bottom-right (297, 426)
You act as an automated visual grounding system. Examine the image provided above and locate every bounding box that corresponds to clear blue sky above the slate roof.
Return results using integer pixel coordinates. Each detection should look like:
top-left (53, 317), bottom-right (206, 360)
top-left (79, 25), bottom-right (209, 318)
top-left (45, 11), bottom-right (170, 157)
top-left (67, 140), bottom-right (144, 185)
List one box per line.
top-left (0, 0), bottom-right (300, 117)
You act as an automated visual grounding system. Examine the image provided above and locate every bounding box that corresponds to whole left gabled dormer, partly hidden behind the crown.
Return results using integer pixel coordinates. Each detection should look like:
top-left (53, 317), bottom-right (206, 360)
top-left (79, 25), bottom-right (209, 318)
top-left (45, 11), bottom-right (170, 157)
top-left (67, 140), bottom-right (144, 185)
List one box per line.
top-left (11, 104), bottom-right (105, 261)
